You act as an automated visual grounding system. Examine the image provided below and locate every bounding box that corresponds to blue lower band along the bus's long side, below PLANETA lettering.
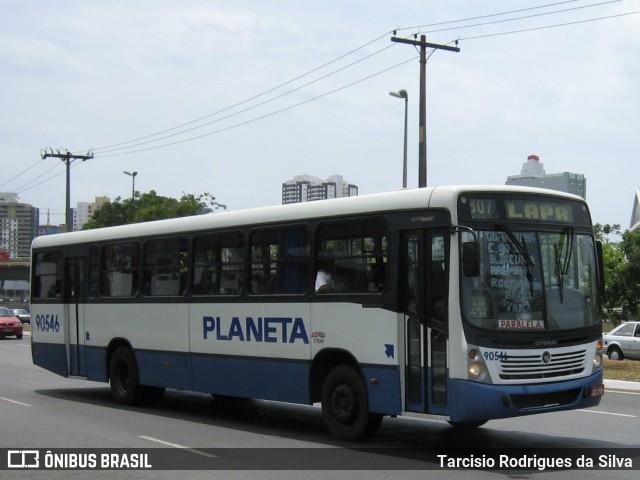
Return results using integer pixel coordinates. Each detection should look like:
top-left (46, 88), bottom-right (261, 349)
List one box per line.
top-left (32, 343), bottom-right (402, 415)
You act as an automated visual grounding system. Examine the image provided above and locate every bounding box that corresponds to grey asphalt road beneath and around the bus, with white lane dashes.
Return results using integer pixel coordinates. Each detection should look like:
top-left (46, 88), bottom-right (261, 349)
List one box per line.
top-left (0, 336), bottom-right (640, 480)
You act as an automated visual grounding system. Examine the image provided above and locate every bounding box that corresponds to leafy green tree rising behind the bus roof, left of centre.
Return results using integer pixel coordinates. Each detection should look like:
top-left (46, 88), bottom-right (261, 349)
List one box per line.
top-left (83, 190), bottom-right (227, 230)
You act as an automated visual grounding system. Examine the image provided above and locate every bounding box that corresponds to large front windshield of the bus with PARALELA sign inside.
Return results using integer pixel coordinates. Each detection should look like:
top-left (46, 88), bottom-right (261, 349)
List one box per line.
top-left (461, 228), bottom-right (599, 331)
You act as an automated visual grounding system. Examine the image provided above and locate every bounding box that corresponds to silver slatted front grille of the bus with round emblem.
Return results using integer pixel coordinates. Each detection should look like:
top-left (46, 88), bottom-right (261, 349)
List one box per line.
top-left (500, 350), bottom-right (587, 380)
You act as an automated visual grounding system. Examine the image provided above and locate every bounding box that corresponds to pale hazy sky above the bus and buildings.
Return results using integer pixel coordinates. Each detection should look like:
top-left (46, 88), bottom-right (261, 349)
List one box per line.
top-left (0, 0), bottom-right (640, 230)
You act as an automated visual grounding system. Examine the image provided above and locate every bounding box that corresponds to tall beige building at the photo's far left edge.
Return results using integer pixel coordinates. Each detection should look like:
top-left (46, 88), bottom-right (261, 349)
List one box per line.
top-left (0, 192), bottom-right (40, 258)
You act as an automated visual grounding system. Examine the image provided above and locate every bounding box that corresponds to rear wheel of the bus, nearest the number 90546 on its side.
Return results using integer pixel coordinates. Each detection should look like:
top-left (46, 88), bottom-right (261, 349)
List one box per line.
top-left (109, 347), bottom-right (164, 405)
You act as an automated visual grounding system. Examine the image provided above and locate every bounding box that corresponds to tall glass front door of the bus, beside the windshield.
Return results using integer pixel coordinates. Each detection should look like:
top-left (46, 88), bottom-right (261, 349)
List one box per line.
top-left (401, 229), bottom-right (449, 413)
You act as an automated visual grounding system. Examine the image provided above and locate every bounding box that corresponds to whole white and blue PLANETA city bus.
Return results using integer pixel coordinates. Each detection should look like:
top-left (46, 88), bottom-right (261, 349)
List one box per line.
top-left (31, 186), bottom-right (604, 440)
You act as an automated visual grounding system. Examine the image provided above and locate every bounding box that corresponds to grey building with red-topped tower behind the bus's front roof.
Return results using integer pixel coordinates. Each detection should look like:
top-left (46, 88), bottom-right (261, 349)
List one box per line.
top-left (505, 155), bottom-right (587, 198)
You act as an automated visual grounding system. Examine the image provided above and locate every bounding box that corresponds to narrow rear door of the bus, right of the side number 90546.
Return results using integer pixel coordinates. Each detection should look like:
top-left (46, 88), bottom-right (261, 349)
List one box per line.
top-left (64, 257), bottom-right (87, 377)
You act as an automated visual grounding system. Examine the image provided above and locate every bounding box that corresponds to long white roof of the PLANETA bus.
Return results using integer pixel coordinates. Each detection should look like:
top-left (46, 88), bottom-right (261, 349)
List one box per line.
top-left (32, 185), bottom-right (584, 248)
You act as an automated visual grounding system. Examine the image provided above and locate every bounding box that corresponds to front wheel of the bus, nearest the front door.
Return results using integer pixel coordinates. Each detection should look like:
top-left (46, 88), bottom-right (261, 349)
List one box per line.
top-left (322, 365), bottom-right (382, 440)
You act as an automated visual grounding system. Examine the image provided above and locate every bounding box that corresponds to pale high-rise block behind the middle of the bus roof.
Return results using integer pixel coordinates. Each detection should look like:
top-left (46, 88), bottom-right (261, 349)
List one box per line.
top-left (282, 175), bottom-right (358, 204)
